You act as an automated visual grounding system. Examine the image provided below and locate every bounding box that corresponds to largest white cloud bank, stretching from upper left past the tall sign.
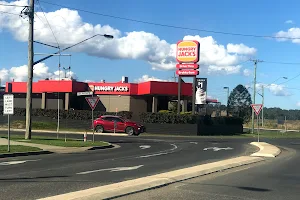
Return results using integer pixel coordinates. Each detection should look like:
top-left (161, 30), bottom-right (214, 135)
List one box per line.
top-left (0, 0), bottom-right (256, 74)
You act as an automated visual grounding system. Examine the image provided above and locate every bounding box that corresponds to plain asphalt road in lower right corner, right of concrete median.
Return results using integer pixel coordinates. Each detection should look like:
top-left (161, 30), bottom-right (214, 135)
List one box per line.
top-left (119, 139), bottom-right (300, 200)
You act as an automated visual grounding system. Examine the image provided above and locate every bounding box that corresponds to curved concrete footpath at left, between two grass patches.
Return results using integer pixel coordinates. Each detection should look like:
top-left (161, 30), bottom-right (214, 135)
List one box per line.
top-left (0, 138), bottom-right (113, 153)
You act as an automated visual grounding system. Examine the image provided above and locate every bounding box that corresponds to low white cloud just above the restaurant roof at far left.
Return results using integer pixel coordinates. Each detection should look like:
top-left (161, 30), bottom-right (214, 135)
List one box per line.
top-left (0, 63), bottom-right (76, 82)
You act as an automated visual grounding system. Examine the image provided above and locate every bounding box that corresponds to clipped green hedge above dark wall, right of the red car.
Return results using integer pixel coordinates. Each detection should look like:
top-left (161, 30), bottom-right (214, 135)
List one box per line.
top-left (140, 113), bottom-right (243, 125)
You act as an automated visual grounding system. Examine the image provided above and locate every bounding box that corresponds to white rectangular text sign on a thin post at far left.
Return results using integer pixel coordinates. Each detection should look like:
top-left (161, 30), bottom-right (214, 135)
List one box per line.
top-left (3, 94), bottom-right (14, 152)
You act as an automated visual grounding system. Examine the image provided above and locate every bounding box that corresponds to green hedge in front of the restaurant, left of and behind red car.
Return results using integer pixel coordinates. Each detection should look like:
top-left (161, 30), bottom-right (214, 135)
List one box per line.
top-left (14, 108), bottom-right (132, 120)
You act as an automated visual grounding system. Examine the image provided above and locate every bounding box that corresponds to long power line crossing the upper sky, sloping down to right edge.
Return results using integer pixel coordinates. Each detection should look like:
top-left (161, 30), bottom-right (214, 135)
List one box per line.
top-left (41, 1), bottom-right (300, 40)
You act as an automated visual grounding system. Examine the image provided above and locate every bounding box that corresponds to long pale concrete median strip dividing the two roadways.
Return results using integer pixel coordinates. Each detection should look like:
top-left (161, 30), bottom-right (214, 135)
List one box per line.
top-left (38, 143), bottom-right (280, 200)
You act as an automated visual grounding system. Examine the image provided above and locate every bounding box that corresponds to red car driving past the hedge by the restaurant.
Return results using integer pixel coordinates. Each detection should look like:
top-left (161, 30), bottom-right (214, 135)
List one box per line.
top-left (94, 115), bottom-right (145, 135)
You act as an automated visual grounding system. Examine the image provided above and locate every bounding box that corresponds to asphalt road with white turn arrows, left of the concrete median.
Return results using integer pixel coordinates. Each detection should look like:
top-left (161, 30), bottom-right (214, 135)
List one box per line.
top-left (0, 132), bottom-right (256, 200)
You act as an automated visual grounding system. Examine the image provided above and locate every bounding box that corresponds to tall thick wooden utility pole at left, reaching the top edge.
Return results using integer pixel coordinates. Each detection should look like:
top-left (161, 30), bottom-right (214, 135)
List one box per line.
top-left (25, 0), bottom-right (34, 139)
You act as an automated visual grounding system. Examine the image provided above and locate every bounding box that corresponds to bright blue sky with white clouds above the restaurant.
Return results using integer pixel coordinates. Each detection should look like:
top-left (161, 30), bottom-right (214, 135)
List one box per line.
top-left (0, 0), bottom-right (300, 109)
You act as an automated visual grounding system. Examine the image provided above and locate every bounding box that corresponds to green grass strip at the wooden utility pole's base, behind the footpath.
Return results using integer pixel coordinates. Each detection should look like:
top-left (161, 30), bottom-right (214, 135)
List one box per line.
top-left (0, 135), bottom-right (109, 147)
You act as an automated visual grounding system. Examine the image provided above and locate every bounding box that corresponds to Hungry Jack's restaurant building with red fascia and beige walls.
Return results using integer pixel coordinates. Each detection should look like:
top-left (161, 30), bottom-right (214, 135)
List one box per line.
top-left (5, 77), bottom-right (216, 113)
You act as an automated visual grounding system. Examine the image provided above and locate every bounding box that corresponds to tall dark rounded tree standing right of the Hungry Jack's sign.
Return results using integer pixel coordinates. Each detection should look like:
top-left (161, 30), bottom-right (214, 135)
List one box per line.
top-left (227, 85), bottom-right (252, 122)
